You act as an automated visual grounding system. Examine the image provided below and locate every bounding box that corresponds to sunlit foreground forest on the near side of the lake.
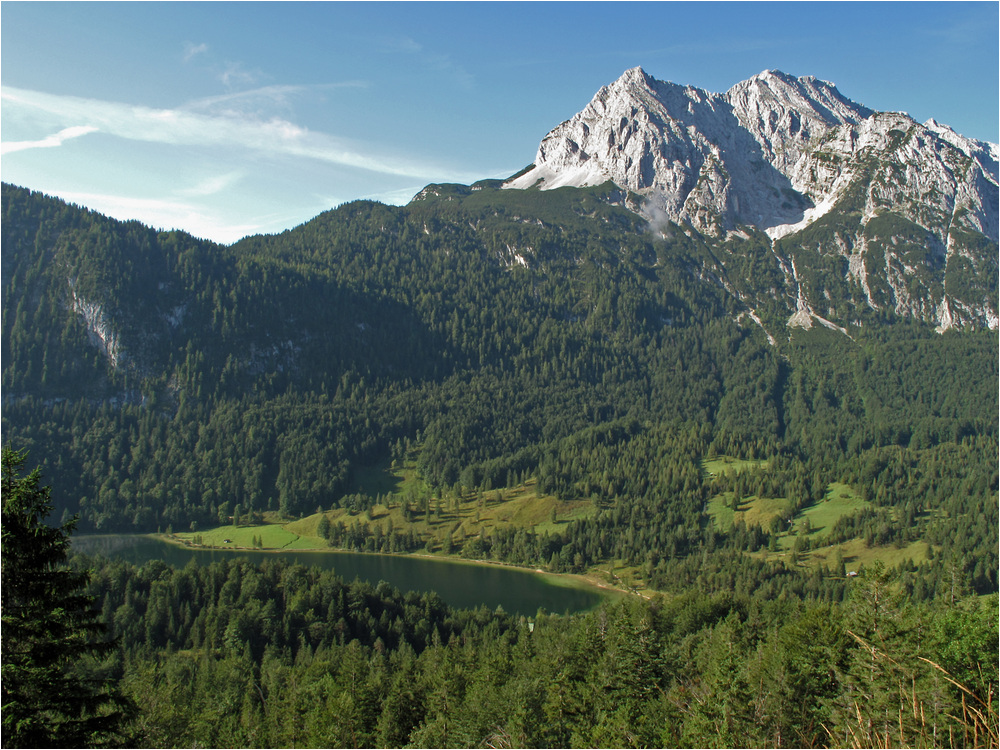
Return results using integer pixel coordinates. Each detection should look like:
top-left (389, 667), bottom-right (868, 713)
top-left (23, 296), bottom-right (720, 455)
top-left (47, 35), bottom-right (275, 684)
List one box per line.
top-left (74, 560), bottom-right (997, 748)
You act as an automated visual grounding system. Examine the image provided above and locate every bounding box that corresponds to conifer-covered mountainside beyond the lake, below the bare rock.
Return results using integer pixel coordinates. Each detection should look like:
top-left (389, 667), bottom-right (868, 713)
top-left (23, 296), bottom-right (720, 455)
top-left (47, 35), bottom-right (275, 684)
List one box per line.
top-left (2, 182), bottom-right (998, 599)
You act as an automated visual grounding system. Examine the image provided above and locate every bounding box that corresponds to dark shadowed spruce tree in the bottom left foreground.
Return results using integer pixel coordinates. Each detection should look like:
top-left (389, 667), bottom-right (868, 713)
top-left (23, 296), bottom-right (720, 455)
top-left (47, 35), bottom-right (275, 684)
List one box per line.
top-left (0, 446), bottom-right (131, 747)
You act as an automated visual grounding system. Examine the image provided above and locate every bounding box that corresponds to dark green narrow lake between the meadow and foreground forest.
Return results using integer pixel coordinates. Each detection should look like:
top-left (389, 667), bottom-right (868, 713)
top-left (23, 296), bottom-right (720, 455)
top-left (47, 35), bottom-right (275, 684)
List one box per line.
top-left (73, 535), bottom-right (601, 616)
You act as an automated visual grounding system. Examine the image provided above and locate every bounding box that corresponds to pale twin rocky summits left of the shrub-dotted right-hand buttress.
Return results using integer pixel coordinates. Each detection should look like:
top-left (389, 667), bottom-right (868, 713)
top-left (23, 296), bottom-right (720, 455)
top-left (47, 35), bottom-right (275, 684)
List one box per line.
top-left (506, 67), bottom-right (868, 229)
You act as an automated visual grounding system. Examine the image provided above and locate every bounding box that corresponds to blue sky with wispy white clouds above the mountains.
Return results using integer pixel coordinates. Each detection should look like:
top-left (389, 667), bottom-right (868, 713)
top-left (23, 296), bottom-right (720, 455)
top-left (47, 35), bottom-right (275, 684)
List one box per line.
top-left (0, 2), bottom-right (1000, 242)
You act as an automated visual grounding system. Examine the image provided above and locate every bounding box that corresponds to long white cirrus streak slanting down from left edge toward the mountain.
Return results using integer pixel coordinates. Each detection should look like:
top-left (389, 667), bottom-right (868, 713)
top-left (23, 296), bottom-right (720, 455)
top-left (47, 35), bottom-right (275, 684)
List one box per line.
top-left (0, 86), bottom-right (453, 179)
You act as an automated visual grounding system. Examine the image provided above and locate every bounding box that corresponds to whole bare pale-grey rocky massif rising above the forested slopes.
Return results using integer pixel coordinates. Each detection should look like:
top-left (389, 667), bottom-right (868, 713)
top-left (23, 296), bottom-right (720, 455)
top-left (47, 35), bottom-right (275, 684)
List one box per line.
top-left (505, 68), bottom-right (1000, 329)
